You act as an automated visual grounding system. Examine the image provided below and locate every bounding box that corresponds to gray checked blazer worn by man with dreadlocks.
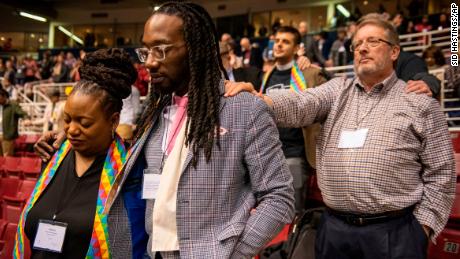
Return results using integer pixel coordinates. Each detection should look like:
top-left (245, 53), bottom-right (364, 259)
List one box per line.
top-left (106, 82), bottom-right (294, 259)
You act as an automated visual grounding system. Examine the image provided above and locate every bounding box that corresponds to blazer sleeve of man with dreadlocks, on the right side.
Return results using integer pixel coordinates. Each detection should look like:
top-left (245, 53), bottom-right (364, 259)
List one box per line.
top-left (232, 99), bottom-right (294, 259)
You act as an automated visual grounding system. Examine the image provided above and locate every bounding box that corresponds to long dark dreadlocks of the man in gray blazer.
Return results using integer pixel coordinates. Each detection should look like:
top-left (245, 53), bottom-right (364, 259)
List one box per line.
top-left (136, 2), bottom-right (228, 167)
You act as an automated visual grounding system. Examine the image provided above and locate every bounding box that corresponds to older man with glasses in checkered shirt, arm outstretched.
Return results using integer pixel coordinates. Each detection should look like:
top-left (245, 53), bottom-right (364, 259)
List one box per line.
top-left (227, 13), bottom-right (455, 259)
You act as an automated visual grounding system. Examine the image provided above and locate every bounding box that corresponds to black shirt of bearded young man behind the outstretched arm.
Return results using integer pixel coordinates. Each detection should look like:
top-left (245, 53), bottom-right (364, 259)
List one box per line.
top-left (264, 68), bottom-right (305, 158)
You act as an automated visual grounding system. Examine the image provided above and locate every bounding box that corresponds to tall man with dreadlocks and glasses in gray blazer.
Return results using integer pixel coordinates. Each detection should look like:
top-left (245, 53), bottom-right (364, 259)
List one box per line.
top-left (106, 2), bottom-right (294, 258)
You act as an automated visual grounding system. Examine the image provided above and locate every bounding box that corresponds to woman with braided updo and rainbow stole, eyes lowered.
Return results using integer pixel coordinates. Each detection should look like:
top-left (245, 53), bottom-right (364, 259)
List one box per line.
top-left (14, 49), bottom-right (137, 259)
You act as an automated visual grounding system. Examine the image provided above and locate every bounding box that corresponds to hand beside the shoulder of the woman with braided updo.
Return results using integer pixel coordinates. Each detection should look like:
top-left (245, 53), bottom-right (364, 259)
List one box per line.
top-left (34, 131), bottom-right (65, 162)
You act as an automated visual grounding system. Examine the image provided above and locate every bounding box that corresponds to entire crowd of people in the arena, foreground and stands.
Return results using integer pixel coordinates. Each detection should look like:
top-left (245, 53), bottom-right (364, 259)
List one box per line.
top-left (0, 2), bottom-right (457, 259)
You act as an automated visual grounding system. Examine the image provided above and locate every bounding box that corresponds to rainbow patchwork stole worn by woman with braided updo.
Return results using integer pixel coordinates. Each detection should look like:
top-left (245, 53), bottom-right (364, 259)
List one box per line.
top-left (13, 135), bottom-right (127, 259)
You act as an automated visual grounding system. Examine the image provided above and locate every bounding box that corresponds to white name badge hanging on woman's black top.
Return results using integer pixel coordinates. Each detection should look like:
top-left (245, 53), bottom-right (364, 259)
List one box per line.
top-left (33, 219), bottom-right (67, 253)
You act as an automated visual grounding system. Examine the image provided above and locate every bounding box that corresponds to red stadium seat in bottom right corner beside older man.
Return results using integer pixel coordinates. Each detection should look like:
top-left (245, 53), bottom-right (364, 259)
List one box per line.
top-left (428, 228), bottom-right (460, 259)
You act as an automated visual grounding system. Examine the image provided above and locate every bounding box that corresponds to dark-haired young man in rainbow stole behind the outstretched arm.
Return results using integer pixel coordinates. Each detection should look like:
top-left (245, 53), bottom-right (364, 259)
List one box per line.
top-left (253, 26), bottom-right (326, 214)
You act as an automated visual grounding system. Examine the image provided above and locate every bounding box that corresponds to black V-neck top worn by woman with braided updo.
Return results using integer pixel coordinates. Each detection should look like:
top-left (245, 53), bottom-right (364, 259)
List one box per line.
top-left (24, 150), bottom-right (106, 259)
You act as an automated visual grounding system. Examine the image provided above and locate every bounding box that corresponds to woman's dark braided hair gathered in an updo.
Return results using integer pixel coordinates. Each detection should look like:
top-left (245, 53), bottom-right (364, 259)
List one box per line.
top-left (71, 48), bottom-right (137, 116)
